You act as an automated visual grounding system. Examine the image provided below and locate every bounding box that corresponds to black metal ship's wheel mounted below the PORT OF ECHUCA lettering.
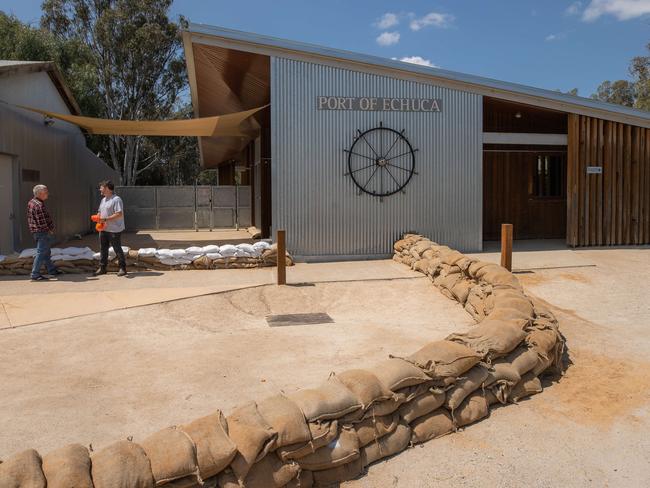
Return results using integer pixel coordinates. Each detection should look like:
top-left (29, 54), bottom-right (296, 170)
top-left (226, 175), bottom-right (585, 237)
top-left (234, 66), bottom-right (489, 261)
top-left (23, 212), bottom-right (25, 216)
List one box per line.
top-left (344, 122), bottom-right (417, 198)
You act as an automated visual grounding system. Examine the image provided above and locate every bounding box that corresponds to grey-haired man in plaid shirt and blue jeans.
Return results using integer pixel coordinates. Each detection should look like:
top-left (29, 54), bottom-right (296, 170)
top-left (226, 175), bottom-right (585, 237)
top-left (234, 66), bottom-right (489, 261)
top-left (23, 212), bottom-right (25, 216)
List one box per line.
top-left (27, 185), bottom-right (61, 281)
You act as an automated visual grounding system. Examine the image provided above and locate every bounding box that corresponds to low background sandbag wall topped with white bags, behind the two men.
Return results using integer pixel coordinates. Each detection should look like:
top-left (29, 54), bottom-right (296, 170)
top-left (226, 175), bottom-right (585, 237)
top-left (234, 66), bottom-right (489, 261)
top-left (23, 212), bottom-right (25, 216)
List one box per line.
top-left (0, 241), bottom-right (293, 276)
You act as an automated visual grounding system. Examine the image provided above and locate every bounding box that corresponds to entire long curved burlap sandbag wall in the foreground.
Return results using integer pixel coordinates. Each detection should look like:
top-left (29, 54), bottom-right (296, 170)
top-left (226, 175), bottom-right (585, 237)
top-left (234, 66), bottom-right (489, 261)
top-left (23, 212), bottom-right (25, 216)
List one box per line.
top-left (0, 235), bottom-right (564, 488)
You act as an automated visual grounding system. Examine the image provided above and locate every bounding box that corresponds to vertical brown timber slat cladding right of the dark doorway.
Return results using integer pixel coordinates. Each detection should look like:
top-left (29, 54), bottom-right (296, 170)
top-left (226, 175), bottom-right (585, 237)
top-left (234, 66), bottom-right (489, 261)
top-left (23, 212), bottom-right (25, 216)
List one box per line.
top-left (566, 114), bottom-right (650, 246)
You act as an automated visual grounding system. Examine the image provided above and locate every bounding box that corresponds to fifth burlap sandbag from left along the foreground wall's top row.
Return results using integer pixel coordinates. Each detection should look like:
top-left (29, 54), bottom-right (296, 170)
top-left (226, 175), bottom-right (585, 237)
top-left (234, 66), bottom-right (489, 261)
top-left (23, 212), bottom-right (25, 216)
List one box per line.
top-left (178, 410), bottom-right (237, 479)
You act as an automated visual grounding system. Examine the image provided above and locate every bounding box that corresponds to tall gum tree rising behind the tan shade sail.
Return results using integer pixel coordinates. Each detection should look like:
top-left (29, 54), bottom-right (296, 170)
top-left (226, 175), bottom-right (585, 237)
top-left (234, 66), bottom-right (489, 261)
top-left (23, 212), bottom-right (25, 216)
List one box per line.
top-left (41, 0), bottom-right (196, 185)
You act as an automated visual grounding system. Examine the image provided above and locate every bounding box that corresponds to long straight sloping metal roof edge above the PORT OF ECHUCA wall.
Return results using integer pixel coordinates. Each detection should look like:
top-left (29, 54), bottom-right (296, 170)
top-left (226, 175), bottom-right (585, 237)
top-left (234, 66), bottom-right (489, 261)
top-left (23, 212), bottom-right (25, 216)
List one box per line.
top-left (186, 23), bottom-right (650, 126)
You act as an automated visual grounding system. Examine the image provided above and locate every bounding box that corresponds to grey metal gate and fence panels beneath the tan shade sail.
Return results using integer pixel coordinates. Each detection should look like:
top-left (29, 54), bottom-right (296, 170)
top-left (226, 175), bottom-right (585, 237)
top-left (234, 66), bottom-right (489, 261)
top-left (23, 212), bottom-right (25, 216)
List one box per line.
top-left (115, 185), bottom-right (251, 230)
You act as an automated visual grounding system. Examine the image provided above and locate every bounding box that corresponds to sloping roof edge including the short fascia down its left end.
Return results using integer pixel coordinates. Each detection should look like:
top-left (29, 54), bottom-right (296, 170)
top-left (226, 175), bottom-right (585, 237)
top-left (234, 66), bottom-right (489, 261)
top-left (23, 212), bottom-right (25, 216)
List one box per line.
top-left (183, 23), bottom-right (650, 127)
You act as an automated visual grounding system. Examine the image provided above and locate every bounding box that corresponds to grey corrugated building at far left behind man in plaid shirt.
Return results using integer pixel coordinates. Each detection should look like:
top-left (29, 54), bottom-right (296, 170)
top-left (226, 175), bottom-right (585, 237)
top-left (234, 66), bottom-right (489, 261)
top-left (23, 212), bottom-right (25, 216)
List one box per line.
top-left (0, 61), bottom-right (117, 254)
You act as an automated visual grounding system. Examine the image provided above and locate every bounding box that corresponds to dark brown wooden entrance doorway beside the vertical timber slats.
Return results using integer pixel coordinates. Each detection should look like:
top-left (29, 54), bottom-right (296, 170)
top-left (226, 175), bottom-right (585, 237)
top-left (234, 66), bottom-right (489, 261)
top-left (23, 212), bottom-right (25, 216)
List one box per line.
top-left (483, 150), bottom-right (567, 240)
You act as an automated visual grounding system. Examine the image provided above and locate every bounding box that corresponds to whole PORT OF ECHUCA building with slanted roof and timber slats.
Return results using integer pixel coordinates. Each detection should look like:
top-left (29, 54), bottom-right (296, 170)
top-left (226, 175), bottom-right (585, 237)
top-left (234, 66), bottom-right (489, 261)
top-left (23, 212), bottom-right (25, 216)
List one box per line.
top-left (184, 24), bottom-right (650, 260)
